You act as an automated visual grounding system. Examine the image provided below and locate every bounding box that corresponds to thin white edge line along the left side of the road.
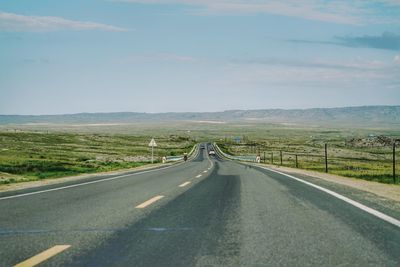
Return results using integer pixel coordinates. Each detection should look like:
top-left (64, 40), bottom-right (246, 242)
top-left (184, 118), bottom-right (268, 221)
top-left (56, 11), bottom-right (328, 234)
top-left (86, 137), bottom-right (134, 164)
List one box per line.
top-left (0, 159), bottom-right (192, 201)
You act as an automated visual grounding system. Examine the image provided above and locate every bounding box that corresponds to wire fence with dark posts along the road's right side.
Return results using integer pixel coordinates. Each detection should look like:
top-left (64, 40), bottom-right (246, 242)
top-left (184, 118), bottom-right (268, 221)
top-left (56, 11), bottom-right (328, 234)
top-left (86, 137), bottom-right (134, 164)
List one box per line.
top-left (217, 143), bottom-right (400, 183)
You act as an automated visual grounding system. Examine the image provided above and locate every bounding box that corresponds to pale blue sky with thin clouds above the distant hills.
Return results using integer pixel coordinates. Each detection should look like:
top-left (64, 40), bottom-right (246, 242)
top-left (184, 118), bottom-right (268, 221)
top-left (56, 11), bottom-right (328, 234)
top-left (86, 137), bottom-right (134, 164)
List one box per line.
top-left (0, 0), bottom-right (400, 114)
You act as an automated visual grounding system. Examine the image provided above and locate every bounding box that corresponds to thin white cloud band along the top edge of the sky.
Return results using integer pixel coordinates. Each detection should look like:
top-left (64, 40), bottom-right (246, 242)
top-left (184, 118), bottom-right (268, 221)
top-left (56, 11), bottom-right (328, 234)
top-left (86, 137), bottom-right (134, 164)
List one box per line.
top-left (110, 0), bottom-right (400, 24)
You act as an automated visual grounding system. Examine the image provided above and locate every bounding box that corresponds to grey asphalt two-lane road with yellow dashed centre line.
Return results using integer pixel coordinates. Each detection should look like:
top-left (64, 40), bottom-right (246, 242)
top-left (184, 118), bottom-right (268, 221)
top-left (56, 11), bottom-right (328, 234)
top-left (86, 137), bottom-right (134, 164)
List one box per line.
top-left (0, 146), bottom-right (400, 266)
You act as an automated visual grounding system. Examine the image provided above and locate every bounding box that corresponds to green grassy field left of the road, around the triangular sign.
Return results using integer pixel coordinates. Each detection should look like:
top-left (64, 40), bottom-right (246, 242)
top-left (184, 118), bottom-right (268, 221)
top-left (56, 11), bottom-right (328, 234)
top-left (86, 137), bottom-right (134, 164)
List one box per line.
top-left (0, 131), bottom-right (194, 184)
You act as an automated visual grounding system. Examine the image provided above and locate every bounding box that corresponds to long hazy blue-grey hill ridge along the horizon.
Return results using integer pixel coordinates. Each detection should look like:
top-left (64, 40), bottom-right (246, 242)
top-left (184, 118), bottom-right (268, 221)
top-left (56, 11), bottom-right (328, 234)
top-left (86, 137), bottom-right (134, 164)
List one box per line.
top-left (0, 106), bottom-right (400, 127)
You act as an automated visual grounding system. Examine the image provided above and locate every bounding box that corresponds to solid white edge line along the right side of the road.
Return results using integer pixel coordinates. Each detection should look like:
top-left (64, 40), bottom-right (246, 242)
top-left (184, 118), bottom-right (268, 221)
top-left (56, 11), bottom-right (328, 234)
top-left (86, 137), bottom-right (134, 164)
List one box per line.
top-left (261, 167), bottom-right (400, 227)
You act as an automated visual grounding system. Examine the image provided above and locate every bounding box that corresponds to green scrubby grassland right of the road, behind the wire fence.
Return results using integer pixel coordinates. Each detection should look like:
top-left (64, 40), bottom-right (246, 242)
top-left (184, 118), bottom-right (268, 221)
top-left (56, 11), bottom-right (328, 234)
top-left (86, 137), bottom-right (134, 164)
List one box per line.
top-left (218, 128), bottom-right (400, 184)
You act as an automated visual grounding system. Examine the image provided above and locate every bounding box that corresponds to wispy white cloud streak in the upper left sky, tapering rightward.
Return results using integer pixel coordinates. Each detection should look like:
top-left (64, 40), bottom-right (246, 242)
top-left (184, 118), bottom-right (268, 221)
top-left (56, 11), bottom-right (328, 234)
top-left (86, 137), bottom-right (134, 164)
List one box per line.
top-left (0, 11), bottom-right (125, 32)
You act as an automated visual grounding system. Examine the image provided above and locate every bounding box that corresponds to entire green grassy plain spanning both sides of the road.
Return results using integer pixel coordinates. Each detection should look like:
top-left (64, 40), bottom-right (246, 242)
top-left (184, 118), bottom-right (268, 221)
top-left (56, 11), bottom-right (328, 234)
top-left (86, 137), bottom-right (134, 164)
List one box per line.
top-left (0, 122), bottom-right (400, 183)
